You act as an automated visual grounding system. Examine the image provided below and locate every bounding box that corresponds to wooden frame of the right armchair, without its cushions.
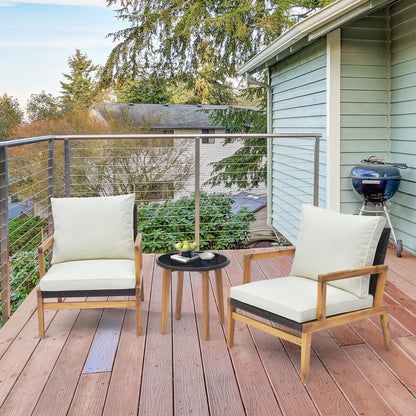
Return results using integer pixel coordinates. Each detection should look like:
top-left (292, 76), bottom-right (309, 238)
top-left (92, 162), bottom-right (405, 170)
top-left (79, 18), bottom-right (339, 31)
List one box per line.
top-left (227, 229), bottom-right (391, 382)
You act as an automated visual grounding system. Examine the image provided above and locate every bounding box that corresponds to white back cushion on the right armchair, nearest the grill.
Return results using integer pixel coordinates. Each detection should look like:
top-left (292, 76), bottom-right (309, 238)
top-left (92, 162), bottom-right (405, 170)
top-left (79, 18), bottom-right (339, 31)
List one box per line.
top-left (291, 205), bottom-right (385, 297)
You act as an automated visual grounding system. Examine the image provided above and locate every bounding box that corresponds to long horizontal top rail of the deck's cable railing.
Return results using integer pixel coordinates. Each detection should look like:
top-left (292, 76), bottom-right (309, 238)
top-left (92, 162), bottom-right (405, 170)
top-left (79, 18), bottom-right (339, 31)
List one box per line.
top-left (0, 133), bottom-right (322, 148)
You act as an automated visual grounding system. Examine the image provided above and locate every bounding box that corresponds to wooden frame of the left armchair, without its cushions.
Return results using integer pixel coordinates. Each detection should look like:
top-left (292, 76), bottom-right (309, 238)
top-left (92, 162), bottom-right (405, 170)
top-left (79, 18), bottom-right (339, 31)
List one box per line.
top-left (37, 234), bottom-right (144, 338)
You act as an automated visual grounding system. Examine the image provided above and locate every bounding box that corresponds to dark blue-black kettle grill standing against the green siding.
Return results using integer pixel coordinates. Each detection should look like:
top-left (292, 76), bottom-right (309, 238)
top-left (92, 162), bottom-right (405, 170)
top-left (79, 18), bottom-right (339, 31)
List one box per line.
top-left (350, 156), bottom-right (407, 257)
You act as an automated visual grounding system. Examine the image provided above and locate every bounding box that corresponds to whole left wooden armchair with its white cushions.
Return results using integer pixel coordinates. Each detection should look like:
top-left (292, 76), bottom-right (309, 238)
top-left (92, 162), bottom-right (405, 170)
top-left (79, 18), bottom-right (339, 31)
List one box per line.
top-left (37, 194), bottom-right (143, 338)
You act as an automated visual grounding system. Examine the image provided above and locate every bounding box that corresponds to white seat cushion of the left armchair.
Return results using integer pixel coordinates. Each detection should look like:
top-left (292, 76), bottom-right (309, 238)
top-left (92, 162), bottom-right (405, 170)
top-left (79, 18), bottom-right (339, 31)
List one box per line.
top-left (40, 259), bottom-right (136, 291)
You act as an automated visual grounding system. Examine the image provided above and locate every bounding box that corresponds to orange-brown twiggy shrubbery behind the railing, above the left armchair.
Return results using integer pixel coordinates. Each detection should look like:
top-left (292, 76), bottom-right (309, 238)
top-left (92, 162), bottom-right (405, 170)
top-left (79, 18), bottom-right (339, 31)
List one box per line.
top-left (10, 110), bottom-right (194, 204)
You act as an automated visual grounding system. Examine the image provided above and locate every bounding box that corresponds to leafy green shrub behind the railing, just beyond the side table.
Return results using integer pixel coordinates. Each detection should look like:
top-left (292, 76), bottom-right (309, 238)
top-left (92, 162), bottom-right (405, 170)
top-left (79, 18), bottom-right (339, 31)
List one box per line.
top-left (137, 193), bottom-right (254, 253)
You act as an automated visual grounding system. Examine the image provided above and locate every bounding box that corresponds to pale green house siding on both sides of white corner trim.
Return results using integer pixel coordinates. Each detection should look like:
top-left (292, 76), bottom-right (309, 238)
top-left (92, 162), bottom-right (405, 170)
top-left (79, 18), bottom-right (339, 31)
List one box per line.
top-left (269, 0), bottom-right (416, 254)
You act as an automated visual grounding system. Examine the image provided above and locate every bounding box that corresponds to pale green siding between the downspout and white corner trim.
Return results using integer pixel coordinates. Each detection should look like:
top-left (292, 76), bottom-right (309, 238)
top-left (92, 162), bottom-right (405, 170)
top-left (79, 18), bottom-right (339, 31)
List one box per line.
top-left (271, 39), bottom-right (326, 244)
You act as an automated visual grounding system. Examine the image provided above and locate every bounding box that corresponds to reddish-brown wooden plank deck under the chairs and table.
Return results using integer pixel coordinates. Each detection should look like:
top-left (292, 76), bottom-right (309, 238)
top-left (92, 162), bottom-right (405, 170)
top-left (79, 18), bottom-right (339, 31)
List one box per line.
top-left (0, 248), bottom-right (416, 416)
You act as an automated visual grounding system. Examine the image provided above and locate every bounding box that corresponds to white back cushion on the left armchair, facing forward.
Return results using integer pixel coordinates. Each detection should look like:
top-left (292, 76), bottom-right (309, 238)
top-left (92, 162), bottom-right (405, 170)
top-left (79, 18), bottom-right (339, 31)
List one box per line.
top-left (51, 194), bottom-right (134, 264)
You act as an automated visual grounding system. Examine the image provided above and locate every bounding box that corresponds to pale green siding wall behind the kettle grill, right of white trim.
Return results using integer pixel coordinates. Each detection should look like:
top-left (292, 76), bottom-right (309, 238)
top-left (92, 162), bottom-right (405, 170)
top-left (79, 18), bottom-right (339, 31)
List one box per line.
top-left (341, 0), bottom-right (416, 253)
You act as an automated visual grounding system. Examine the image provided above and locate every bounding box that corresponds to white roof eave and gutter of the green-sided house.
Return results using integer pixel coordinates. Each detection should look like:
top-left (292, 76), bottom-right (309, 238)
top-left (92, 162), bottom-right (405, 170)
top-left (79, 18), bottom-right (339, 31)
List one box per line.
top-left (237, 0), bottom-right (396, 75)
